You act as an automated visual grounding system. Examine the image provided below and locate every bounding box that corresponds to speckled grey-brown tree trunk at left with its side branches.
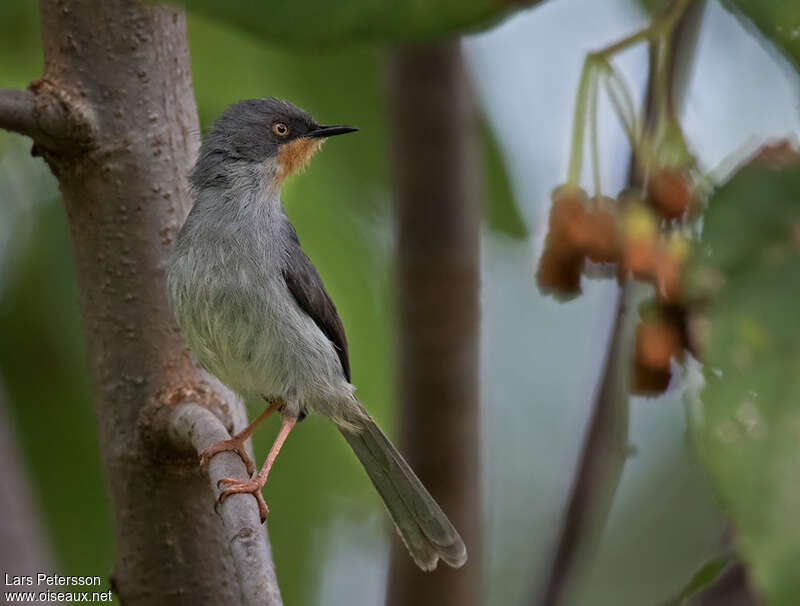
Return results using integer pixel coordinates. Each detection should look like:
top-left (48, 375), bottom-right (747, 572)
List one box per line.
top-left (0, 0), bottom-right (280, 606)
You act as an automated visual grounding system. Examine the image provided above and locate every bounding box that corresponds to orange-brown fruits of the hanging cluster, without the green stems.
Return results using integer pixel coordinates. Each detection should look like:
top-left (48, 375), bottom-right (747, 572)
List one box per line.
top-left (536, 173), bottom-right (698, 394)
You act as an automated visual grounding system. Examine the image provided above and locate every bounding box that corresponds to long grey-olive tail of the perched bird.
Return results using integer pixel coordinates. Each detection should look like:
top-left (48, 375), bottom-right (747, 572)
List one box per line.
top-left (339, 411), bottom-right (467, 570)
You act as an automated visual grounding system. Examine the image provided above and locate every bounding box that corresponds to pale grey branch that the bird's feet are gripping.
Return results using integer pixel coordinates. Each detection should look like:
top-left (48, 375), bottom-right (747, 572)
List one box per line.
top-left (153, 403), bottom-right (281, 606)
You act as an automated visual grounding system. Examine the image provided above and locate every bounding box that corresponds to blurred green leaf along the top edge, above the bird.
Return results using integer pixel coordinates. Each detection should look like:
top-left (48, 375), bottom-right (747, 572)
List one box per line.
top-left (177, 0), bottom-right (538, 47)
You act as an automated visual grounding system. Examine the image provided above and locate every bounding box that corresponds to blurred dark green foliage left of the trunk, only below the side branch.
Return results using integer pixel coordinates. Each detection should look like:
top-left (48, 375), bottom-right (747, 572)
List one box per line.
top-left (0, 172), bottom-right (111, 574)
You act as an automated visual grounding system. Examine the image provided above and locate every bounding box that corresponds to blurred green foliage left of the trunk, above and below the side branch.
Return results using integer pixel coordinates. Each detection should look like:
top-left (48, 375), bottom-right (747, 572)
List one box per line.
top-left (0, 2), bottom-right (112, 574)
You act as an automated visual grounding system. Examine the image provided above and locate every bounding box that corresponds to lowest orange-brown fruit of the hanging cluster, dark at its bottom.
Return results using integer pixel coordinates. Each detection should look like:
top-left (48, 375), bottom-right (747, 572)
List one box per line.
top-left (632, 320), bottom-right (684, 394)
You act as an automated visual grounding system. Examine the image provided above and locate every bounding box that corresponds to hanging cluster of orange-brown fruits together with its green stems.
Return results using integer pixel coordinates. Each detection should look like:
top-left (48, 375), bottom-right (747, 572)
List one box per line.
top-left (536, 7), bottom-right (702, 394)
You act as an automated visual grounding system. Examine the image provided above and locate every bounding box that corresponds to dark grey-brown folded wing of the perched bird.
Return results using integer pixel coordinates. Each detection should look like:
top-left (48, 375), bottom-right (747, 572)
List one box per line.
top-left (283, 218), bottom-right (350, 381)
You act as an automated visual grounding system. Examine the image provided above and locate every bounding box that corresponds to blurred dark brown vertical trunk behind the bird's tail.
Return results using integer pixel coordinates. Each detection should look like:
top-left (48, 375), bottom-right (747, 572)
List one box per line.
top-left (389, 40), bottom-right (481, 606)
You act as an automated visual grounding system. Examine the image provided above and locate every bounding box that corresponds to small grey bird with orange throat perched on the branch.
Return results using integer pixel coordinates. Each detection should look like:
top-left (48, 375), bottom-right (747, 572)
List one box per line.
top-left (167, 98), bottom-right (467, 570)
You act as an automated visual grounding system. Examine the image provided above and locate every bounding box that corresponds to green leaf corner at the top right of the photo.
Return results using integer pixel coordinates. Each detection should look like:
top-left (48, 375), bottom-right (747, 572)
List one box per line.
top-left (723, 0), bottom-right (800, 70)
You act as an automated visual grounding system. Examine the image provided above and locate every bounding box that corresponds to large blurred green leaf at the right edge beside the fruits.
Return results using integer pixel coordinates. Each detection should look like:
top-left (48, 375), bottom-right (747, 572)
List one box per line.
top-left (689, 163), bottom-right (800, 606)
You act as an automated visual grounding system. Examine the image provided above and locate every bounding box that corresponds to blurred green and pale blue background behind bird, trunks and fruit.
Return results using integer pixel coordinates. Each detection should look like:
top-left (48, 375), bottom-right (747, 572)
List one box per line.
top-left (0, 0), bottom-right (800, 605)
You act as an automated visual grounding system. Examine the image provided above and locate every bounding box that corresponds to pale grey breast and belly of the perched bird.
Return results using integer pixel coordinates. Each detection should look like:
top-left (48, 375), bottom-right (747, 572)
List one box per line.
top-left (167, 200), bottom-right (355, 418)
